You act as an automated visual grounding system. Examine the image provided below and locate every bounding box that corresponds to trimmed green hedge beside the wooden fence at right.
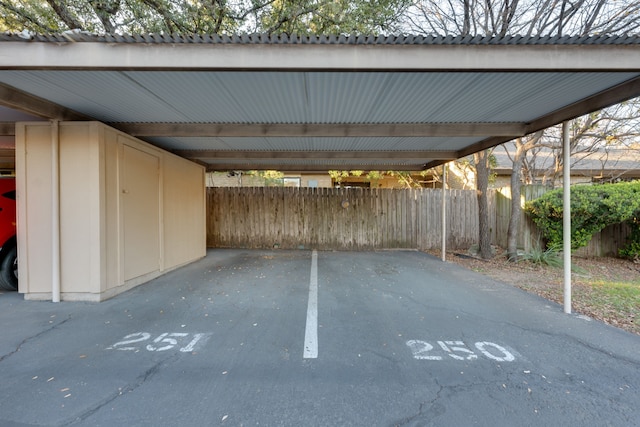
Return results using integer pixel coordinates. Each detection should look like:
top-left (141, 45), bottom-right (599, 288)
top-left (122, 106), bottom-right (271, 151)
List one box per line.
top-left (525, 181), bottom-right (640, 258)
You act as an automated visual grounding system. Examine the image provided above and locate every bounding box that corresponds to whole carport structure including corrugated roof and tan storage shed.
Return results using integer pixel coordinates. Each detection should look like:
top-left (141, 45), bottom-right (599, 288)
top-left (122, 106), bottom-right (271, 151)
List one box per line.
top-left (0, 32), bottom-right (640, 306)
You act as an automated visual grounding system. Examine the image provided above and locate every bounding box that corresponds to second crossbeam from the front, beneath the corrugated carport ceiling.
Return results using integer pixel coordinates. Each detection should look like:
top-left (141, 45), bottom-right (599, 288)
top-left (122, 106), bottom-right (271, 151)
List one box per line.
top-left (119, 123), bottom-right (526, 137)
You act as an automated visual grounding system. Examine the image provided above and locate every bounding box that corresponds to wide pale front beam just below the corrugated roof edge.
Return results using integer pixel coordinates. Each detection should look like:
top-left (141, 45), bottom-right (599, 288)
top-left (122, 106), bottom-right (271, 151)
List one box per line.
top-left (0, 41), bottom-right (640, 72)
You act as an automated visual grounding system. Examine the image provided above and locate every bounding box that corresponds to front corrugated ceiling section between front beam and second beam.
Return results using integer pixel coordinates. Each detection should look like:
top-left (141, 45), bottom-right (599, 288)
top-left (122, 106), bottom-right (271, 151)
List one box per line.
top-left (0, 70), bottom-right (638, 124)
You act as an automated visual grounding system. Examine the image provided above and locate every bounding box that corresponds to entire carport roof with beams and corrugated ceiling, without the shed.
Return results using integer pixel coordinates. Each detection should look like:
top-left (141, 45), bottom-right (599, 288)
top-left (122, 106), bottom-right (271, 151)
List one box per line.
top-left (0, 32), bottom-right (640, 171)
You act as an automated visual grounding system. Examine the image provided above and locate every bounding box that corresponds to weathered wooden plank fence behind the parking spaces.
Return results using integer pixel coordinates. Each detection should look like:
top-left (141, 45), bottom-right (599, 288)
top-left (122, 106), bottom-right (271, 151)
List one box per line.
top-left (207, 187), bottom-right (628, 256)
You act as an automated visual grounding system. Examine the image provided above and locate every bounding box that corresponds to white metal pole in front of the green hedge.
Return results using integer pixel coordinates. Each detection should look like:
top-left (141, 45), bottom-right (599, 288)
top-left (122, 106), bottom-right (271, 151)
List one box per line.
top-left (562, 122), bottom-right (571, 314)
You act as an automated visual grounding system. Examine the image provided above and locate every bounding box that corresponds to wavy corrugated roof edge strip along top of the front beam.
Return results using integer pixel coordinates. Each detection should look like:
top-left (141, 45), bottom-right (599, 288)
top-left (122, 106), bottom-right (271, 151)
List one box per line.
top-left (0, 30), bottom-right (640, 46)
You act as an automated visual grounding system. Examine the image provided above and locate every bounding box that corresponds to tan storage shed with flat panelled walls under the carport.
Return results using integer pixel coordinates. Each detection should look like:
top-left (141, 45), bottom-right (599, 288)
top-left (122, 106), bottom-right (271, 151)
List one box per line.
top-left (16, 122), bottom-right (206, 301)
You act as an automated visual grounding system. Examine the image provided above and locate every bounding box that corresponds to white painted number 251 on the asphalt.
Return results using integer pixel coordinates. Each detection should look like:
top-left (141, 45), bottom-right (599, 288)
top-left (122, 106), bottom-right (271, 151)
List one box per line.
top-left (107, 332), bottom-right (210, 353)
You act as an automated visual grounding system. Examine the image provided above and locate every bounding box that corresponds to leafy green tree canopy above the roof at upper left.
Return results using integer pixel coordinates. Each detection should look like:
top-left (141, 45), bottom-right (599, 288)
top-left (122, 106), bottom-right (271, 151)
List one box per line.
top-left (0, 0), bottom-right (411, 34)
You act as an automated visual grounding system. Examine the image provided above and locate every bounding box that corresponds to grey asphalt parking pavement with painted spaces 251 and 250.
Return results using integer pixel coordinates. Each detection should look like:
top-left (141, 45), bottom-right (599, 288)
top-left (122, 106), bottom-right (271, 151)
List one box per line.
top-left (0, 250), bottom-right (640, 426)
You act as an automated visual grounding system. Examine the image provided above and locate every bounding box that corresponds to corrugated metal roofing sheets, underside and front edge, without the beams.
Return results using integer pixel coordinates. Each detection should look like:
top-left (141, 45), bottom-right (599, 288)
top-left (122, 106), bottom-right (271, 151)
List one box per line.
top-left (0, 32), bottom-right (640, 169)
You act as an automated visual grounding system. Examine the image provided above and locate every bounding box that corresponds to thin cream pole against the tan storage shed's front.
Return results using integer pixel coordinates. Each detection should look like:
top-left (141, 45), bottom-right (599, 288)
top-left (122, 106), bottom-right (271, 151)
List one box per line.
top-left (51, 120), bottom-right (60, 302)
